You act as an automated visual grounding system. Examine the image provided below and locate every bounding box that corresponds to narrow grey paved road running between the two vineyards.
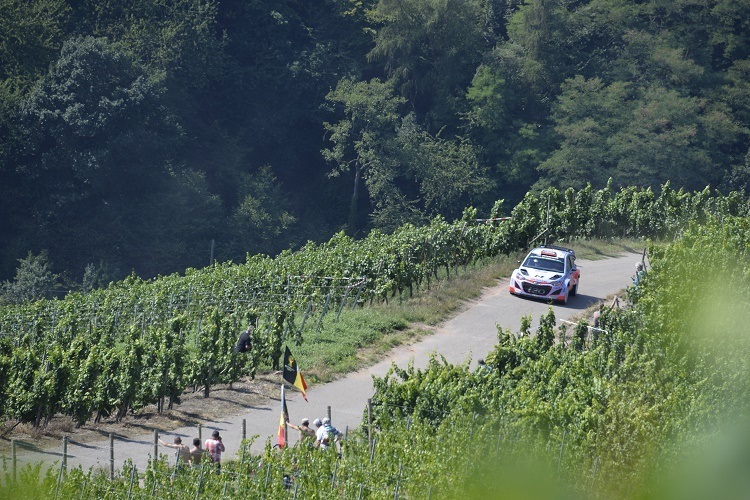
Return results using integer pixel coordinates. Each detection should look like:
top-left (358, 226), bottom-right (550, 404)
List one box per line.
top-left (11, 254), bottom-right (640, 471)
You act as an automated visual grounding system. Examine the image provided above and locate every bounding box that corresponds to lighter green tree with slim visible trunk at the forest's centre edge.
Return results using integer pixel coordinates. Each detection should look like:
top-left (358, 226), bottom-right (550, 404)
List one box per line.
top-left (323, 79), bottom-right (491, 231)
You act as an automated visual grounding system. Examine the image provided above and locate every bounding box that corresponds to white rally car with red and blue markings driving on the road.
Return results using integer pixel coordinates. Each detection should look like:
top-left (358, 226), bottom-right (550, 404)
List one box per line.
top-left (510, 245), bottom-right (581, 304)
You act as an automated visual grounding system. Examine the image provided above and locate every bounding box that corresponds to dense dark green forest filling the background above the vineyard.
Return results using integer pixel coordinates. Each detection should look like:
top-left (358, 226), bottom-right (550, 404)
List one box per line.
top-left (0, 0), bottom-right (750, 293)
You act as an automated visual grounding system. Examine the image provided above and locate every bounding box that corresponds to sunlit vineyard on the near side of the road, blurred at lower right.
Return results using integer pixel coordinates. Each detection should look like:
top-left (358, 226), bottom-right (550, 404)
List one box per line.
top-left (0, 202), bottom-right (750, 499)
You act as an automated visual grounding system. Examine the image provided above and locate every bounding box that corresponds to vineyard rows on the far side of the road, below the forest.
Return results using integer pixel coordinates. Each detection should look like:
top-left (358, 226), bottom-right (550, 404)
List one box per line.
top-left (0, 185), bottom-right (749, 434)
